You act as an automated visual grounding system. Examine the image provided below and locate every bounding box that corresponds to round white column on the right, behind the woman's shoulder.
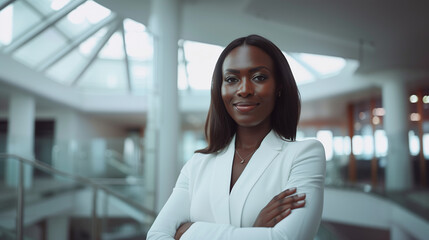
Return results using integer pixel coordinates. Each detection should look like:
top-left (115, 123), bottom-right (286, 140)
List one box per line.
top-left (382, 80), bottom-right (412, 191)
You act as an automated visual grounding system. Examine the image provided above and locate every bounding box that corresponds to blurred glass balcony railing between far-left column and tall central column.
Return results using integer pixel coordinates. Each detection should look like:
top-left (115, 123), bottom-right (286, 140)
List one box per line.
top-left (49, 138), bottom-right (146, 178)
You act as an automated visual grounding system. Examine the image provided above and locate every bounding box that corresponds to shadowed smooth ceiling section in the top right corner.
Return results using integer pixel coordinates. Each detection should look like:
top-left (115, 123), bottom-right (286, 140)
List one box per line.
top-left (246, 0), bottom-right (429, 71)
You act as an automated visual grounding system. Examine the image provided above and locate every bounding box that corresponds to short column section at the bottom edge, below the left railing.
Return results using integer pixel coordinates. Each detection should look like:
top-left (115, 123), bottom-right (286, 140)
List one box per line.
top-left (46, 216), bottom-right (70, 240)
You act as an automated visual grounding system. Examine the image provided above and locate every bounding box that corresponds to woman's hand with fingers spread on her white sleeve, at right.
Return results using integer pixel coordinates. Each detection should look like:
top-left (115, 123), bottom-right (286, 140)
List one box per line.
top-left (253, 188), bottom-right (305, 227)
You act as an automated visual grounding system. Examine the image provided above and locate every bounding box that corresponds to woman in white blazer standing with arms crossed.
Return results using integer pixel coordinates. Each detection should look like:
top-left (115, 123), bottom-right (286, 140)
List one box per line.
top-left (148, 35), bottom-right (325, 240)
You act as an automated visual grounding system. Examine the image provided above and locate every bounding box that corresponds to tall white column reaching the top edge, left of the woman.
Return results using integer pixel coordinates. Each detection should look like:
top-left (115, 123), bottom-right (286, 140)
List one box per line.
top-left (148, 0), bottom-right (180, 211)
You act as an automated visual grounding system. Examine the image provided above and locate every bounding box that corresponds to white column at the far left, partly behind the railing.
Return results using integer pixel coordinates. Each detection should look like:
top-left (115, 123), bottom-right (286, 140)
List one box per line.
top-left (6, 93), bottom-right (36, 188)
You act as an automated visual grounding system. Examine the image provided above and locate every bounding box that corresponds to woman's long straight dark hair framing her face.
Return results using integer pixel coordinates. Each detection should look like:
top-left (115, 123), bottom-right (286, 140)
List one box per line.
top-left (196, 35), bottom-right (301, 154)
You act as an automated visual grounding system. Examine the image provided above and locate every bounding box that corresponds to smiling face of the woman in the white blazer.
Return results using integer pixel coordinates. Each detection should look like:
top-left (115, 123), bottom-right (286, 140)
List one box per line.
top-left (221, 45), bottom-right (276, 127)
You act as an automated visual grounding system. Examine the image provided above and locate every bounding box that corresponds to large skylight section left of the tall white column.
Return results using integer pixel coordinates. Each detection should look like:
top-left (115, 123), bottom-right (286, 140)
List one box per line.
top-left (0, 0), bottom-right (153, 95)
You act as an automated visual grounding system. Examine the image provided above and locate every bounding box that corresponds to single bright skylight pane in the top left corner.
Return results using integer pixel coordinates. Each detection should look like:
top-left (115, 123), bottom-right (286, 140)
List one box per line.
top-left (0, 1), bottom-right (41, 46)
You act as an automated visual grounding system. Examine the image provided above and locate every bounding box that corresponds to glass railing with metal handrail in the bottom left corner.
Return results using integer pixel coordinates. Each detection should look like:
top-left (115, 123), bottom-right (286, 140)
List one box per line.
top-left (0, 154), bottom-right (155, 239)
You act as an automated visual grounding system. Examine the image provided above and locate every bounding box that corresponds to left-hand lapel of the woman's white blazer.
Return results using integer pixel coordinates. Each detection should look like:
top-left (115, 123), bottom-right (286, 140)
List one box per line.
top-left (210, 136), bottom-right (235, 224)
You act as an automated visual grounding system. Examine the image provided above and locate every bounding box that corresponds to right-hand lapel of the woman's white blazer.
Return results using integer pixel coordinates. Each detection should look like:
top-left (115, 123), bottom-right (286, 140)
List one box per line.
top-left (229, 130), bottom-right (283, 226)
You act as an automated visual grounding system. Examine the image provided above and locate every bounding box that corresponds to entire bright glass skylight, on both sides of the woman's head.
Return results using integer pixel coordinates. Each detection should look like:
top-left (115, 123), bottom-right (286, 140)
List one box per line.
top-left (0, 0), bottom-right (346, 94)
